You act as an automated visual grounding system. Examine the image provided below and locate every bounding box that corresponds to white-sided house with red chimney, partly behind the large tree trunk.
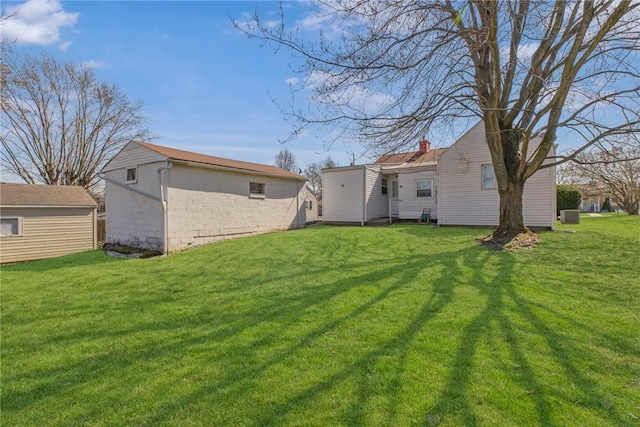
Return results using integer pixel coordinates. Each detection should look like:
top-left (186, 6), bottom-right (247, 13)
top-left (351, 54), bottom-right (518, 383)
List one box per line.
top-left (322, 122), bottom-right (556, 229)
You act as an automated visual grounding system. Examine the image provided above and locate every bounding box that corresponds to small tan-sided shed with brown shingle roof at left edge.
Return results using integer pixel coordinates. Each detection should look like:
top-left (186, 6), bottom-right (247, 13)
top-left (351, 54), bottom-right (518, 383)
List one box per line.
top-left (0, 183), bottom-right (98, 263)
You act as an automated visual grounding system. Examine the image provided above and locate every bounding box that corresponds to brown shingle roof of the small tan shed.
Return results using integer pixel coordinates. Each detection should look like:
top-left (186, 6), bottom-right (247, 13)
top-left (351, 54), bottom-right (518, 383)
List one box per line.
top-left (0, 183), bottom-right (97, 206)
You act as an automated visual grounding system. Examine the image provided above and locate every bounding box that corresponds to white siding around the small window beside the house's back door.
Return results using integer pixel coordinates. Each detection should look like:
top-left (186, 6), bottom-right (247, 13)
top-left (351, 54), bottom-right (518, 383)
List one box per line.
top-left (398, 166), bottom-right (438, 220)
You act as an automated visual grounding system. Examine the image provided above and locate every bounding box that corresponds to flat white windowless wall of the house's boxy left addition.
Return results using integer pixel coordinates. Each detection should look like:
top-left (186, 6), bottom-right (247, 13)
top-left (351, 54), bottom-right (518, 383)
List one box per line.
top-left (322, 166), bottom-right (364, 222)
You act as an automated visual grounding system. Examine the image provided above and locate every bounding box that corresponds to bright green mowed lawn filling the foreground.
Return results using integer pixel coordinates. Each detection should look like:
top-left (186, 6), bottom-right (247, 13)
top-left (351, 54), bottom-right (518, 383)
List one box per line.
top-left (1, 215), bottom-right (640, 426)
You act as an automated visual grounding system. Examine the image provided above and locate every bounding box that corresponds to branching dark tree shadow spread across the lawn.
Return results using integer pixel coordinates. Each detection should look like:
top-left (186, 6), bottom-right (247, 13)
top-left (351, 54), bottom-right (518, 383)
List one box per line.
top-left (2, 226), bottom-right (636, 425)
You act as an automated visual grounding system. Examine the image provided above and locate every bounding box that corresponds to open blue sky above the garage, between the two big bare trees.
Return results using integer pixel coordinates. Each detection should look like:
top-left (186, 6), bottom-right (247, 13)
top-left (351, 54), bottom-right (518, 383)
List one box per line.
top-left (1, 0), bottom-right (366, 169)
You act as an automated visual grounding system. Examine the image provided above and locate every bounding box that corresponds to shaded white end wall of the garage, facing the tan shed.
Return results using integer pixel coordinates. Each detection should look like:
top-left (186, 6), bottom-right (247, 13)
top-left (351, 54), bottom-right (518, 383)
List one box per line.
top-left (105, 162), bottom-right (165, 250)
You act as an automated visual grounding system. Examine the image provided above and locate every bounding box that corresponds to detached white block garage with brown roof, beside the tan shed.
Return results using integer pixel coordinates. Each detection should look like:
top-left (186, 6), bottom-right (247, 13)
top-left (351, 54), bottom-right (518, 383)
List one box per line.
top-left (102, 141), bottom-right (306, 253)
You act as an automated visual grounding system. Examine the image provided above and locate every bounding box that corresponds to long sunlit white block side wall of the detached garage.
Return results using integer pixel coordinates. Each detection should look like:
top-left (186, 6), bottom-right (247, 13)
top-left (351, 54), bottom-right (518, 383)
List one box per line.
top-left (165, 164), bottom-right (305, 252)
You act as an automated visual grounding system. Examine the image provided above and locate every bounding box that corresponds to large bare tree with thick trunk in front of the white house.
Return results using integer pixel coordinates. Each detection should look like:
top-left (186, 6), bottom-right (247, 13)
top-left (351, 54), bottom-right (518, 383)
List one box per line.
top-left (235, 0), bottom-right (640, 236)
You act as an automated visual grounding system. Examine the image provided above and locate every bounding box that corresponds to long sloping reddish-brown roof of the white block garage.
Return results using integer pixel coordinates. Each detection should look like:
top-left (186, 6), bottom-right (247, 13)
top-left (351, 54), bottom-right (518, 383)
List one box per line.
top-left (133, 141), bottom-right (307, 181)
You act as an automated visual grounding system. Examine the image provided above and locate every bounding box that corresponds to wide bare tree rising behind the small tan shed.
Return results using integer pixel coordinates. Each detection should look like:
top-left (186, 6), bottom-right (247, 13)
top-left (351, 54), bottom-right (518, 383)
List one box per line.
top-left (0, 45), bottom-right (150, 188)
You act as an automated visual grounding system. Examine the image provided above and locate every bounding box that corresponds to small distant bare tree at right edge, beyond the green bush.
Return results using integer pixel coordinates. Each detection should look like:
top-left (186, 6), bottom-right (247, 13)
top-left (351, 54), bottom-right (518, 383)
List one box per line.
top-left (569, 139), bottom-right (640, 215)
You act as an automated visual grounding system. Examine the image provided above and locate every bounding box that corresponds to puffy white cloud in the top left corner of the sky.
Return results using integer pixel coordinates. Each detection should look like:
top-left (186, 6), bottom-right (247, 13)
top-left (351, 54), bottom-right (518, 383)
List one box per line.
top-left (2, 0), bottom-right (79, 45)
